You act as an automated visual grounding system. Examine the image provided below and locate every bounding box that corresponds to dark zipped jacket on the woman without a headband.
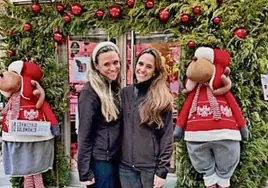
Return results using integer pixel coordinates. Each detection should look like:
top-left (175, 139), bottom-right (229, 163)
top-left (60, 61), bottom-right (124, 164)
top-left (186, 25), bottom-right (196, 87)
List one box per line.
top-left (122, 82), bottom-right (173, 179)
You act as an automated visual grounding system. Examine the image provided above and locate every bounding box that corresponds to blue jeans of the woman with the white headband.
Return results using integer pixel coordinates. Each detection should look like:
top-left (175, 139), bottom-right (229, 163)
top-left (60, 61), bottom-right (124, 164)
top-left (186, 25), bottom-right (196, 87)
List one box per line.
top-left (87, 160), bottom-right (120, 188)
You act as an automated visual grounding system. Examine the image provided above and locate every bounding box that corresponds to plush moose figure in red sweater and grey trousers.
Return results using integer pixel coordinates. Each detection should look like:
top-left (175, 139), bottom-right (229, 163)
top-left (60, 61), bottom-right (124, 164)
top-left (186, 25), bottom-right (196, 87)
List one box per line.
top-left (174, 47), bottom-right (249, 188)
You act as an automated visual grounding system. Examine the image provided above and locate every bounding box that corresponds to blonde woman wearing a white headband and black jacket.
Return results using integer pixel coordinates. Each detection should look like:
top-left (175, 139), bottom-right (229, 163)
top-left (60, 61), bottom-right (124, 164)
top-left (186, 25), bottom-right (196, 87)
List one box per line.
top-left (78, 42), bottom-right (120, 188)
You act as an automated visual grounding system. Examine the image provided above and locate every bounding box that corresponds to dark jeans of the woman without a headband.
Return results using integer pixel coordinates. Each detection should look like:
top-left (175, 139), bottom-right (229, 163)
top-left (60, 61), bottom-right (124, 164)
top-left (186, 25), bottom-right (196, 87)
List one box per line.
top-left (119, 164), bottom-right (154, 188)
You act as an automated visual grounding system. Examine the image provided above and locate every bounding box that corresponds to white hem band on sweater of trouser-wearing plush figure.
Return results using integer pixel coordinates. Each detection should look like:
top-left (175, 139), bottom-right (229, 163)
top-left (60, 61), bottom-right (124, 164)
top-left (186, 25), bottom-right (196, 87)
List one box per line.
top-left (184, 129), bottom-right (241, 142)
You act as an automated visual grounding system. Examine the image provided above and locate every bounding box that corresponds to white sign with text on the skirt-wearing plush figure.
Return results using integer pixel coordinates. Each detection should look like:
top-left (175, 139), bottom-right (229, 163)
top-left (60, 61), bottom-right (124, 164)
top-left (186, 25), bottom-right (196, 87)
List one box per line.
top-left (9, 120), bottom-right (51, 136)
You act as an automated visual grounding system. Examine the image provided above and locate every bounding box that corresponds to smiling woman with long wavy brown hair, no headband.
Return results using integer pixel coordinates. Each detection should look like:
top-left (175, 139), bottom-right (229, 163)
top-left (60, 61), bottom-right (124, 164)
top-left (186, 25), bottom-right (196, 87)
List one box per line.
top-left (119, 48), bottom-right (173, 188)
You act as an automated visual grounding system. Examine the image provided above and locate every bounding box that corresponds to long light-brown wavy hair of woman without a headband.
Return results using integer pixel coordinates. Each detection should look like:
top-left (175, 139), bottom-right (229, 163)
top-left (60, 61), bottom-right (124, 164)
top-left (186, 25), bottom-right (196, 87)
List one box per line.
top-left (137, 48), bottom-right (173, 129)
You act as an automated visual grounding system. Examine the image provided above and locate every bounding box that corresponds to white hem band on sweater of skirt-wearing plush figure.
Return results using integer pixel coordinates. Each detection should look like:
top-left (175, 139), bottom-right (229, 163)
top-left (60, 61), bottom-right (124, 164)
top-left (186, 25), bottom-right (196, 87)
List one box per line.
top-left (2, 131), bottom-right (54, 142)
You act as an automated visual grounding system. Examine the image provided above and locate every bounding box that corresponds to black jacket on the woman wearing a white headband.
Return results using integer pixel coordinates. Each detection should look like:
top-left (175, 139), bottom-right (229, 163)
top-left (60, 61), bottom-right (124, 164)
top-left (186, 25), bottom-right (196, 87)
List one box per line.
top-left (78, 83), bottom-right (121, 181)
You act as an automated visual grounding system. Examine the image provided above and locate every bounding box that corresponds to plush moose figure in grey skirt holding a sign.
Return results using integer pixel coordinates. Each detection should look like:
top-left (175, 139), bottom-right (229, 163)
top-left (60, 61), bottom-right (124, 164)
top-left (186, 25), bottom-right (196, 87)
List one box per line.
top-left (0, 61), bottom-right (60, 188)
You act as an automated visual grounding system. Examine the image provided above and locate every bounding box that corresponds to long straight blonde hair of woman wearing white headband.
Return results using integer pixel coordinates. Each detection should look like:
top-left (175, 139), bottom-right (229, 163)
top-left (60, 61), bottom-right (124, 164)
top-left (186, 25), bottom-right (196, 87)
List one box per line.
top-left (87, 46), bottom-right (119, 122)
